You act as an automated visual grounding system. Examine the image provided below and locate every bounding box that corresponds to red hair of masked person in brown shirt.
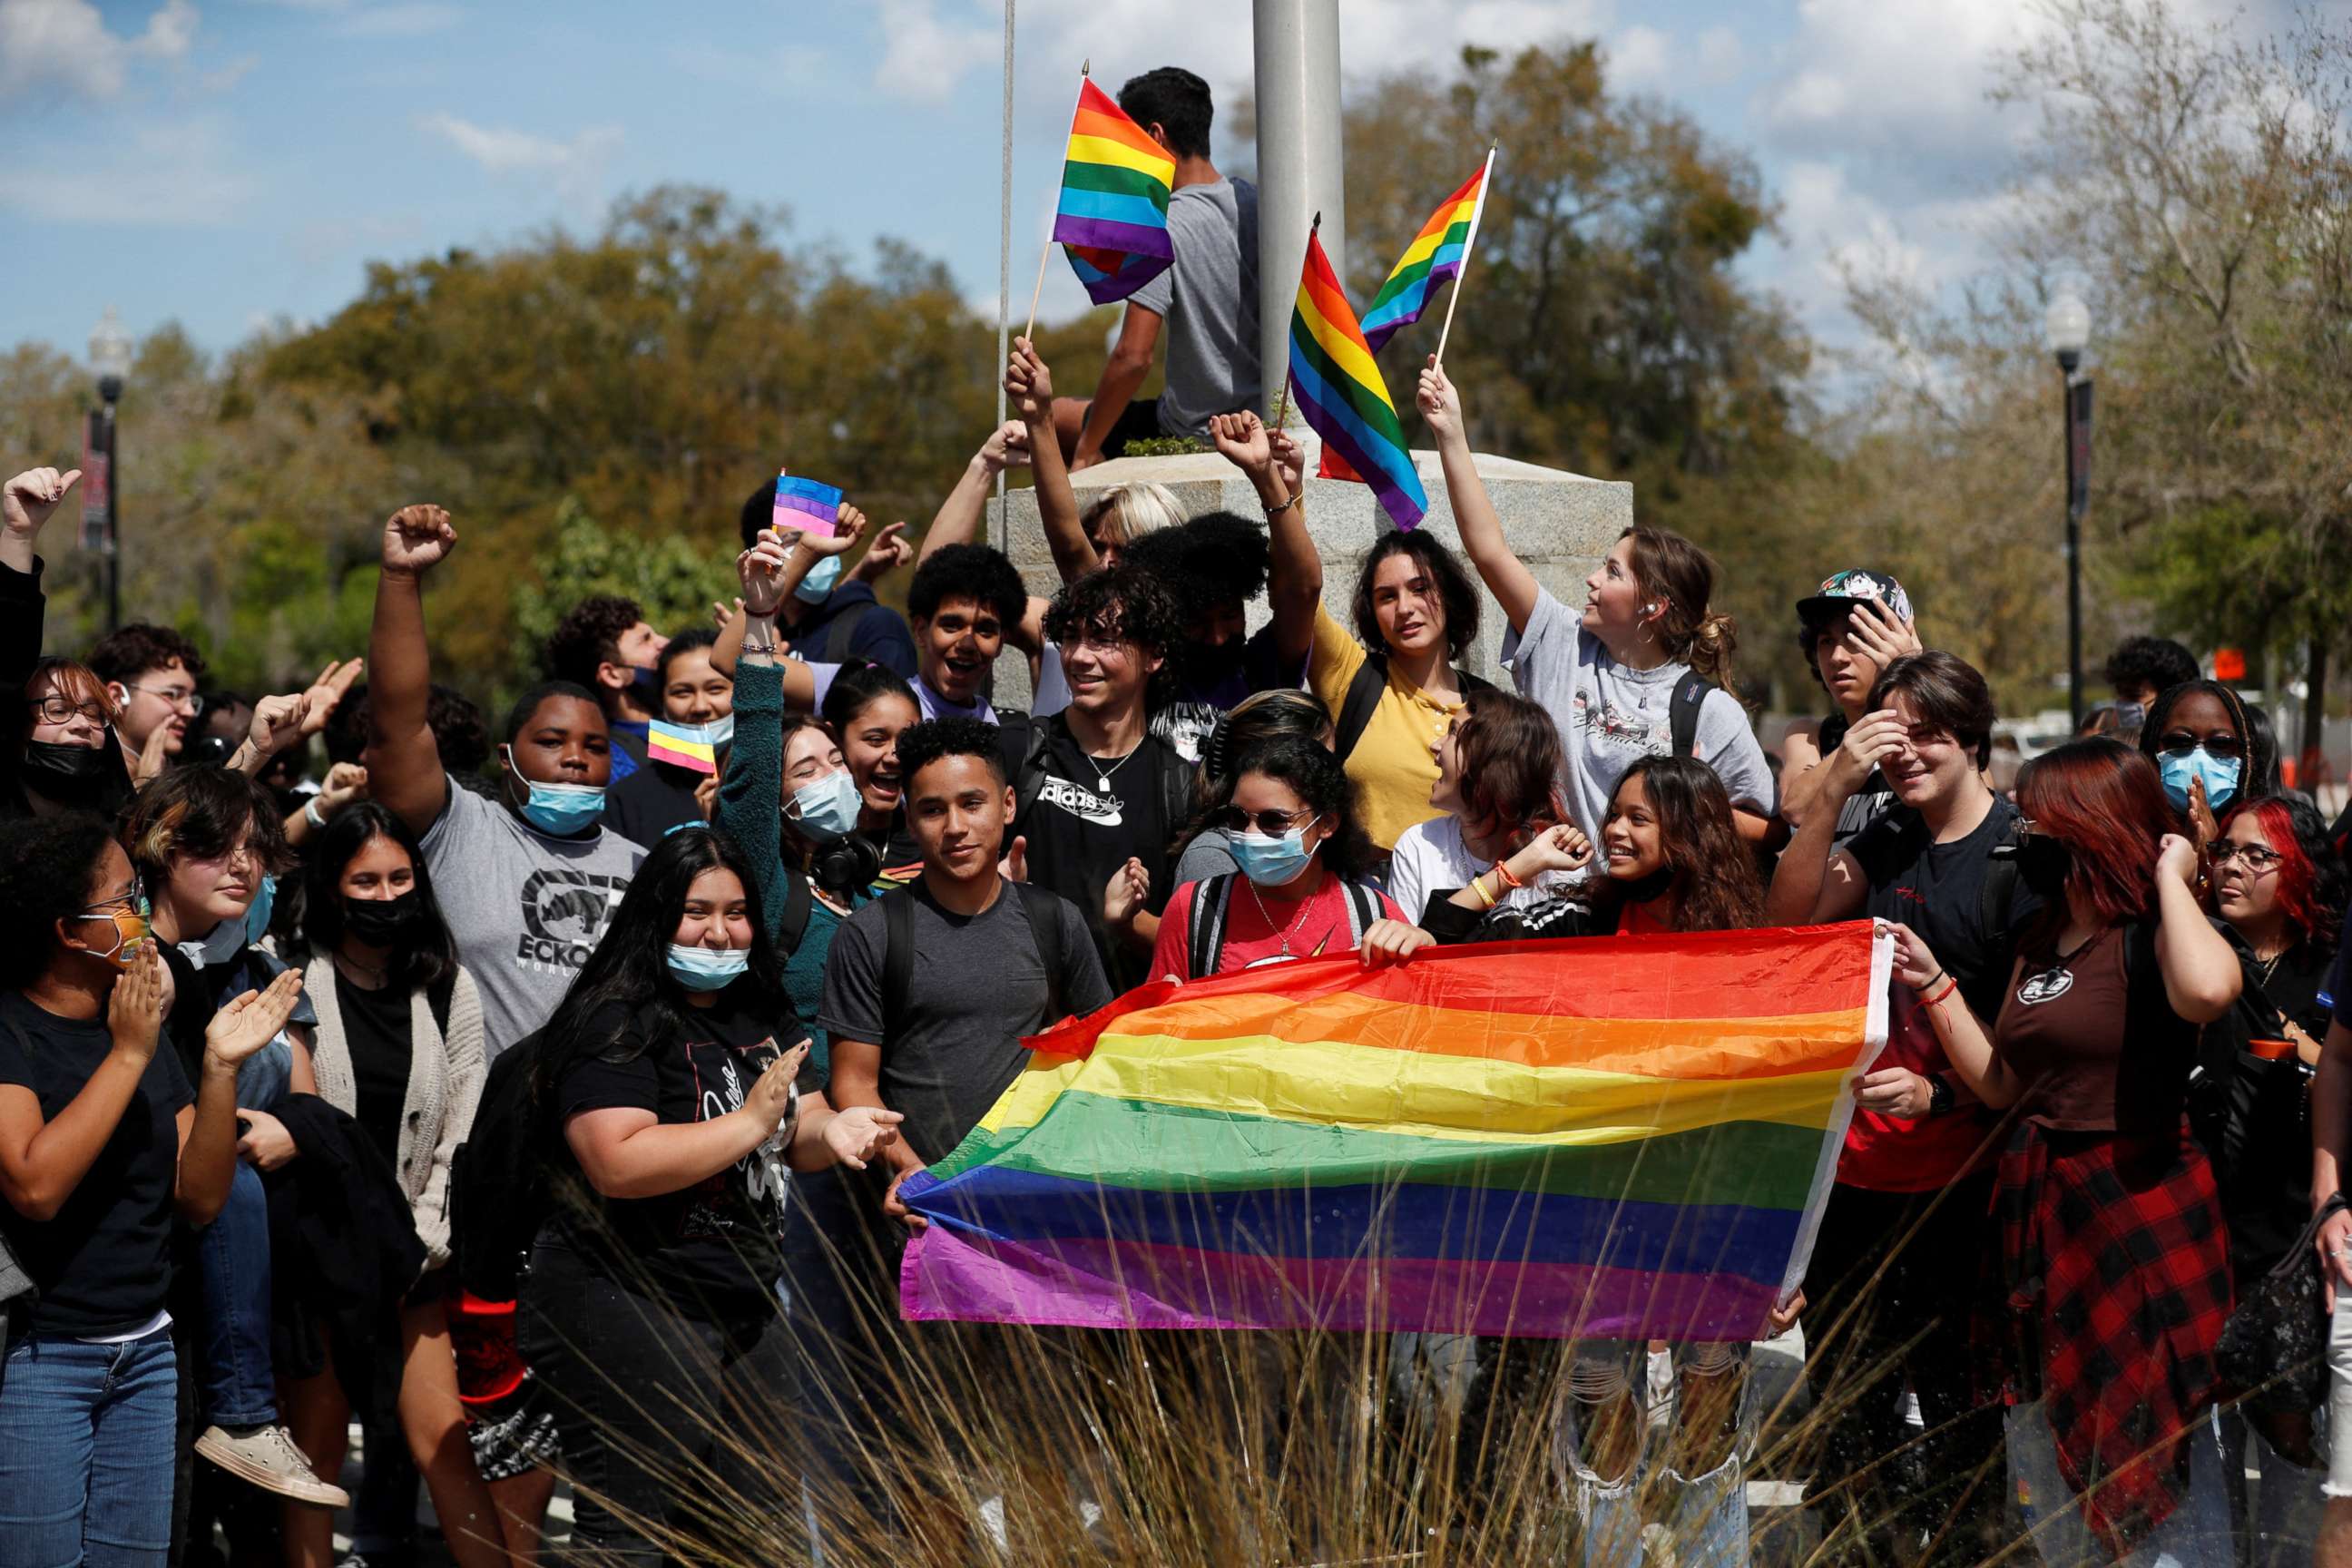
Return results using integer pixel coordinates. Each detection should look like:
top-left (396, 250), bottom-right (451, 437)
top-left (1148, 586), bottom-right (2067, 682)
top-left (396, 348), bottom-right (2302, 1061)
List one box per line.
top-left (2018, 736), bottom-right (2173, 926)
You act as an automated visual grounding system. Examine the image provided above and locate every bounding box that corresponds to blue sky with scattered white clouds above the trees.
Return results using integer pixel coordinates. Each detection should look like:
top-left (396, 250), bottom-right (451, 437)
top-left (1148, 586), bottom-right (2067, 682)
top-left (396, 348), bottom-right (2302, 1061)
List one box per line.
top-left (0, 0), bottom-right (2277, 378)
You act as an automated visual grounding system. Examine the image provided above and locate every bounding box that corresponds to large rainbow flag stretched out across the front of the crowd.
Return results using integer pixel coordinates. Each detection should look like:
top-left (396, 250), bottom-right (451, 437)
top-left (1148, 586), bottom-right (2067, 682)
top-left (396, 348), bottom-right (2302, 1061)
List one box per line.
top-left (898, 922), bottom-right (1888, 1340)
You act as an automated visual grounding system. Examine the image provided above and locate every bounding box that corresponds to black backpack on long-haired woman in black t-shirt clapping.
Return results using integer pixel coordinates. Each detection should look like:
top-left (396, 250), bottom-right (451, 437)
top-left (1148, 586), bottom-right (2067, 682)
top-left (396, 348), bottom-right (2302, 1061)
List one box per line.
top-left (449, 1030), bottom-right (555, 1302)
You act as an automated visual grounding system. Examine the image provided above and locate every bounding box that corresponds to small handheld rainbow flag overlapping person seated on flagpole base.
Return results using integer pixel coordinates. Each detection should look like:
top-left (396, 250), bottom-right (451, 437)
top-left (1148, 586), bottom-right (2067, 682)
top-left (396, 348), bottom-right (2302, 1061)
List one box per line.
top-left (1054, 77), bottom-right (1176, 306)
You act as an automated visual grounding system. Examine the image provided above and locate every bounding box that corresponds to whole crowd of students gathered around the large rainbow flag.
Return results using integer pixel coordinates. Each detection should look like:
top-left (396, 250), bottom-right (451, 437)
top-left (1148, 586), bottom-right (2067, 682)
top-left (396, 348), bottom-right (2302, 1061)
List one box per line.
top-left (14, 73), bottom-right (2352, 1568)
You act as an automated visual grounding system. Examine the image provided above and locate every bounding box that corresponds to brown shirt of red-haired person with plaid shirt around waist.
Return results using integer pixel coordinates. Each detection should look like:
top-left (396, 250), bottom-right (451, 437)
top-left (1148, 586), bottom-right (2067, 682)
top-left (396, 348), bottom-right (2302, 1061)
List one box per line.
top-left (1992, 924), bottom-right (2197, 1138)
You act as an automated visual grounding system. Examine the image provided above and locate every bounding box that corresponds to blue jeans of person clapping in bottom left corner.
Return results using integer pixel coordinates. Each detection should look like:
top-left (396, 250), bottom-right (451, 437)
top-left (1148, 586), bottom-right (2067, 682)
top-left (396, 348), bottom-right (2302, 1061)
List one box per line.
top-left (0, 1328), bottom-right (179, 1568)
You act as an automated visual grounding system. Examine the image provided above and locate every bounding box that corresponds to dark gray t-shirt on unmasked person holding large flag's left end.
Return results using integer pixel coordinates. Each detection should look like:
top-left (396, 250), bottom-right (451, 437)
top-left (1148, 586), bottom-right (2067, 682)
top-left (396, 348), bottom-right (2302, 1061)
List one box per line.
top-left (816, 882), bottom-right (1110, 1161)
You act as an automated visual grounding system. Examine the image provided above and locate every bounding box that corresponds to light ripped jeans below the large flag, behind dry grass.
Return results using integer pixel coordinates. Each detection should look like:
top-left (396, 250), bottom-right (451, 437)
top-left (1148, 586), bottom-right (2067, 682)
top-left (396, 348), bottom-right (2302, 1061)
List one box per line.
top-left (1566, 1340), bottom-right (1749, 1568)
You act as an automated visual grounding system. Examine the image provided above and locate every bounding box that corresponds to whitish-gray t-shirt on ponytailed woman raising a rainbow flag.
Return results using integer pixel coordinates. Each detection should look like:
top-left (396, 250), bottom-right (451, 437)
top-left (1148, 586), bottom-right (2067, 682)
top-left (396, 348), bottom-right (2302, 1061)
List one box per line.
top-left (1503, 593), bottom-right (1773, 860)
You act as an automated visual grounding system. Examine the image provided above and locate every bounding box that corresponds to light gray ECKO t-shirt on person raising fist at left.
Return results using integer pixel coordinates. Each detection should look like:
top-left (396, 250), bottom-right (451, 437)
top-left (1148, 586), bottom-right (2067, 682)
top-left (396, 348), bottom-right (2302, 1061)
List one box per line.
top-left (424, 779), bottom-right (644, 1060)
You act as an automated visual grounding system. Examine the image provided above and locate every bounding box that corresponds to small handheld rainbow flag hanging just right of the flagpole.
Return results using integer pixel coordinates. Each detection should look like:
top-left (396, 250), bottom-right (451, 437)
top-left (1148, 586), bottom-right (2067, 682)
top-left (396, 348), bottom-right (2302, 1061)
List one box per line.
top-left (1291, 232), bottom-right (1430, 529)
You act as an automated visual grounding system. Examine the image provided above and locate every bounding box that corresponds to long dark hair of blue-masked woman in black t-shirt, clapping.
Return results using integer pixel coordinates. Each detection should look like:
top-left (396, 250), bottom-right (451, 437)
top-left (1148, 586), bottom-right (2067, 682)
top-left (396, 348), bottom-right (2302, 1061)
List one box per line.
top-left (536, 825), bottom-right (793, 1105)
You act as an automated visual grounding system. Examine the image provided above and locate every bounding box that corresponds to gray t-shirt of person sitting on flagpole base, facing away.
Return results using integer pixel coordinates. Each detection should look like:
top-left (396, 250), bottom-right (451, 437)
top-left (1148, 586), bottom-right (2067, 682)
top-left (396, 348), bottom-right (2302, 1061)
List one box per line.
top-left (1132, 179), bottom-right (1263, 435)
